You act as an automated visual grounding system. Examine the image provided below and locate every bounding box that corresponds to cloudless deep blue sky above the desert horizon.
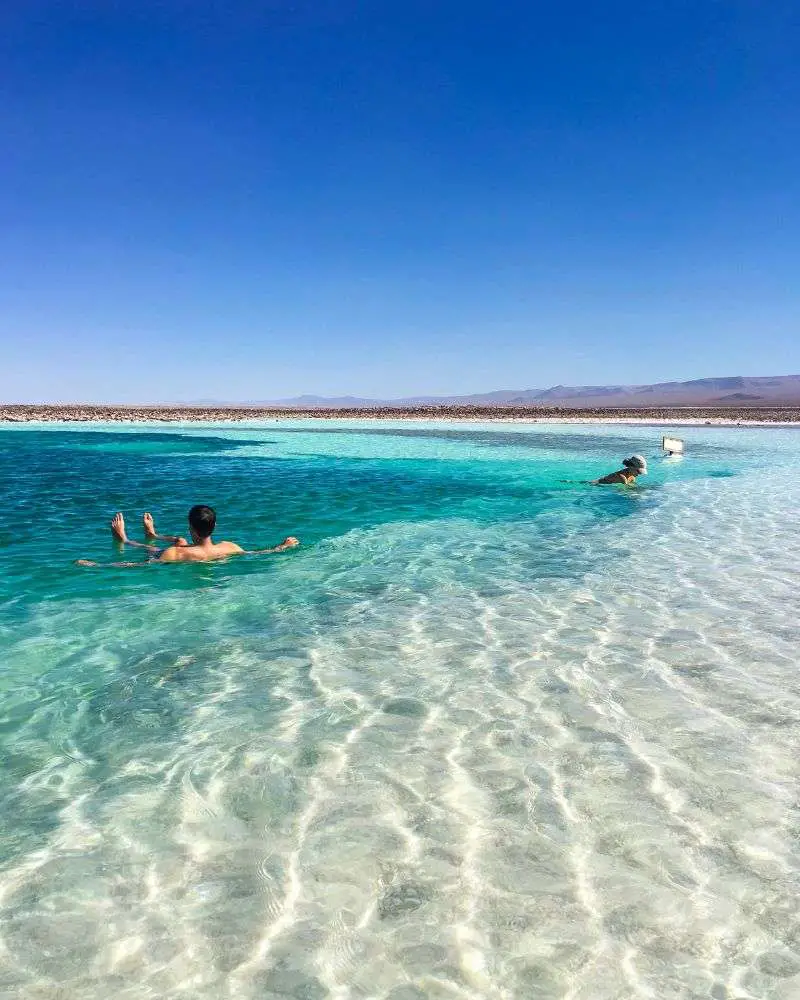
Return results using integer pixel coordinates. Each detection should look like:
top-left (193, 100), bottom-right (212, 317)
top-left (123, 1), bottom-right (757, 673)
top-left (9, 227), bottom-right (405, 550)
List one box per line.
top-left (0, 0), bottom-right (800, 402)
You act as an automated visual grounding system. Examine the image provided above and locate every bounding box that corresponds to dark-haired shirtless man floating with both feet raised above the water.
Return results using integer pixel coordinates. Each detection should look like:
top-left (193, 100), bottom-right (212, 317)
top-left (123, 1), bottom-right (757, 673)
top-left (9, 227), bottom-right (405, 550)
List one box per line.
top-left (78, 504), bottom-right (300, 566)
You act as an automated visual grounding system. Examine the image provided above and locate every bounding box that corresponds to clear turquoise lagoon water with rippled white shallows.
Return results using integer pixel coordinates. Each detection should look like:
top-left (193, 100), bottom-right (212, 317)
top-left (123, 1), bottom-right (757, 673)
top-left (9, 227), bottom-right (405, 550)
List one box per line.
top-left (0, 422), bottom-right (800, 1000)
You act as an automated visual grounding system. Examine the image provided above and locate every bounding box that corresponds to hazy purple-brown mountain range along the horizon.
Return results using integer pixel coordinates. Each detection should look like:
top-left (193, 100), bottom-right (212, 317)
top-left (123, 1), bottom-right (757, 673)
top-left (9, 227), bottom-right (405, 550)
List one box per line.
top-left (255, 375), bottom-right (800, 409)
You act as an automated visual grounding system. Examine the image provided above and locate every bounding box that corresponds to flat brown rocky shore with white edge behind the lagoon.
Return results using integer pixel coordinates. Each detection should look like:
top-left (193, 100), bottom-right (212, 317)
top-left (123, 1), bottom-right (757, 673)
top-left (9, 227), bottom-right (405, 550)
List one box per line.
top-left (0, 403), bottom-right (800, 424)
